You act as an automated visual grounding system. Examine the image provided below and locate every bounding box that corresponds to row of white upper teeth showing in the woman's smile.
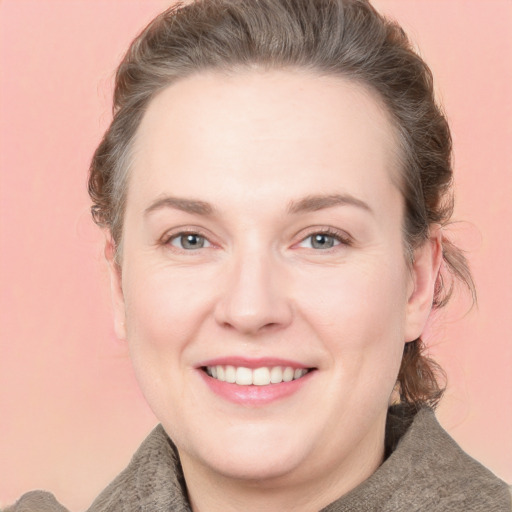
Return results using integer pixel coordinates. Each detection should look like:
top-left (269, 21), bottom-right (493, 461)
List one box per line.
top-left (206, 365), bottom-right (308, 386)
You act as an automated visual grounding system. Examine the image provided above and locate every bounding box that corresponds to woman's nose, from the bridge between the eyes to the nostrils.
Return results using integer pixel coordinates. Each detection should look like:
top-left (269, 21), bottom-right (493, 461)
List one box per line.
top-left (214, 251), bottom-right (293, 335)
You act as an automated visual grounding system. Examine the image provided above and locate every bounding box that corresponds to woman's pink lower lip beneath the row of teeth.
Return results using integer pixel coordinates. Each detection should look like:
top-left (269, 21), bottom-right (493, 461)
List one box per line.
top-left (198, 370), bottom-right (315, 406)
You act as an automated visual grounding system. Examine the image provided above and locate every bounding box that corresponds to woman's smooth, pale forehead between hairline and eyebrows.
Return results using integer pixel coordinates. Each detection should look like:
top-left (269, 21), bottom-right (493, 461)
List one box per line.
top-left (128, 70), bottom-right (399, 214)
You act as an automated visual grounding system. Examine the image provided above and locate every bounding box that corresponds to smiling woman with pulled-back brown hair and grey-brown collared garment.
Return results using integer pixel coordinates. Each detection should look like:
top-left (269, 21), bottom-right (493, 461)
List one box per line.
top-left (7, 0), bottom-right (511, 511)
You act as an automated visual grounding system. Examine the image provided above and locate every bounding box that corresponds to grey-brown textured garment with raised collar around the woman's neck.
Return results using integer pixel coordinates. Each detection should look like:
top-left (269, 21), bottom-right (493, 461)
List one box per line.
top-left (4, 407), bottom-right (512, 512)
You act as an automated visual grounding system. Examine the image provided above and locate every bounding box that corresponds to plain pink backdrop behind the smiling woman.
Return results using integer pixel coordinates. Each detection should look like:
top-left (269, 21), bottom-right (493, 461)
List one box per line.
top-left (0, 0), bottom-right (512, 510)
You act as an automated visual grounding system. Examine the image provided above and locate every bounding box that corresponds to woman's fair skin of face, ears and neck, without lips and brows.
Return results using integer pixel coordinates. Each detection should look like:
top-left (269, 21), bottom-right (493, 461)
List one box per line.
top-left (107, 70), bottom-right (441, 511)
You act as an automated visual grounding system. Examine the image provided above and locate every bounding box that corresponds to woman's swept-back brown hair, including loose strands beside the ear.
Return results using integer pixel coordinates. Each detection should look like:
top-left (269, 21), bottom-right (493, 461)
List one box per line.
top-left (89, 0), bottom-right (475, 408)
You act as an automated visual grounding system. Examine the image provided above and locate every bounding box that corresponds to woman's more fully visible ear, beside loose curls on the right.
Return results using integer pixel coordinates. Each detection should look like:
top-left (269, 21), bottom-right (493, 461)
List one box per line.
top-left (405, 225), bottom-right (443, 342)
